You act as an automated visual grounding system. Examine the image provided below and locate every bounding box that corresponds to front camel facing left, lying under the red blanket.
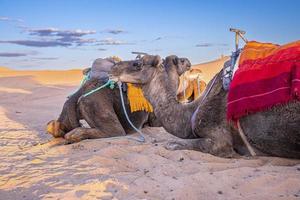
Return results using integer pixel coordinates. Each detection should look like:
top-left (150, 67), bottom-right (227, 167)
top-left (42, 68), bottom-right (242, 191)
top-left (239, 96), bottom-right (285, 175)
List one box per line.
top-left (111, 55), bottom-right (300, 158)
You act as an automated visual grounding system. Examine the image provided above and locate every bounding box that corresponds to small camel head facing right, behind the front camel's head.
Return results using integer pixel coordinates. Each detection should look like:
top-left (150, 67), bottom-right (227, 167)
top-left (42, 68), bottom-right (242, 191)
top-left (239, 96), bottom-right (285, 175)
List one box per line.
top-left (164, 55), bottom-right (192, 76)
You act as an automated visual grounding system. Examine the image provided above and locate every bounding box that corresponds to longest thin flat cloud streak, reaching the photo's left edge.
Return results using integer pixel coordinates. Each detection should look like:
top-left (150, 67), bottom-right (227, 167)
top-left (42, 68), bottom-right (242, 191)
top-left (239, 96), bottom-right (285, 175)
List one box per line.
top-left (0, 40), bottom-right (72, 47)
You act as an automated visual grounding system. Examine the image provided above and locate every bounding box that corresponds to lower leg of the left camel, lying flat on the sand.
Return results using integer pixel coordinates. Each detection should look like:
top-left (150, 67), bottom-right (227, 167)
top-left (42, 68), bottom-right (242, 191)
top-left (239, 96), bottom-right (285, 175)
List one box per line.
top-left (64, 127), bottom-right (123, 144)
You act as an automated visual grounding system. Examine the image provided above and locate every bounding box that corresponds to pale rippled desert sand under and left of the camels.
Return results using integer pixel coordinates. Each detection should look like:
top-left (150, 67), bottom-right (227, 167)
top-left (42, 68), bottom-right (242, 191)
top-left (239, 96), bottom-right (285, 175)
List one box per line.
top-left (0, 66), bottom-right (300, 200)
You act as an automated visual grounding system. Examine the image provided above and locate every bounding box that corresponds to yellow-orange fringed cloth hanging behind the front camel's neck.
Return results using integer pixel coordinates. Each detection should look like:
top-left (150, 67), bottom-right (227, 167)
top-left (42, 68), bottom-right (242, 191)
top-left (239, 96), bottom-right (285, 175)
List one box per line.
top-left (127, 83), bottom-right (153, 112)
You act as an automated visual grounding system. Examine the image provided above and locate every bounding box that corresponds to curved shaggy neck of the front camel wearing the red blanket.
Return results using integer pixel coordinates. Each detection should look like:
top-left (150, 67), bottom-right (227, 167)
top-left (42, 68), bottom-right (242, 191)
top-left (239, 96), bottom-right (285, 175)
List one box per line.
top-left (142, 71), bottom-right (196, 138)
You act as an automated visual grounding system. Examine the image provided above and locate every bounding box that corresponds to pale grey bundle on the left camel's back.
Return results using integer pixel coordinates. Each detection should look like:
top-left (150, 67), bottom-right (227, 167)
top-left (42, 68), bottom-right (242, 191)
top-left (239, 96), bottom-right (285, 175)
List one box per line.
top-left (90, 58), bottom-right (115, 79)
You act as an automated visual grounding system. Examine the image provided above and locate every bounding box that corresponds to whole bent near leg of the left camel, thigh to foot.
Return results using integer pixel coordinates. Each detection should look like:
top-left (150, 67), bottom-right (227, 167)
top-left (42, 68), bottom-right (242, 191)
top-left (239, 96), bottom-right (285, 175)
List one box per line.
top-left (65, 91), bottom-right (126, 143)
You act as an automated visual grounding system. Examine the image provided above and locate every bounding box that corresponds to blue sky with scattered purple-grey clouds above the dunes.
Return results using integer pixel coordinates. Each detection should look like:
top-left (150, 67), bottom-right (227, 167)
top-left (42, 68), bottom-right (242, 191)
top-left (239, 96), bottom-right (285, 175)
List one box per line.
top-left (0, 0), bottom-right (300, 70)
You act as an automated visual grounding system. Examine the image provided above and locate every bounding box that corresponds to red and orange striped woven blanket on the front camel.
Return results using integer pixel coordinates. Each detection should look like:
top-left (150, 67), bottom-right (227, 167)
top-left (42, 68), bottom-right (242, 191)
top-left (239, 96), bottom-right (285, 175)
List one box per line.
top-left (227, 41), bottom-right (300, 122)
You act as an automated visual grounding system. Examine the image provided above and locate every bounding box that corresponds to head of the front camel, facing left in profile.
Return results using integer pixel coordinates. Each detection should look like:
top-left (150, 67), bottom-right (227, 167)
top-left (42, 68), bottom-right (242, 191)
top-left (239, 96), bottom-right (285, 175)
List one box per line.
top-left (110, 55), bottom-right (163, 84)
